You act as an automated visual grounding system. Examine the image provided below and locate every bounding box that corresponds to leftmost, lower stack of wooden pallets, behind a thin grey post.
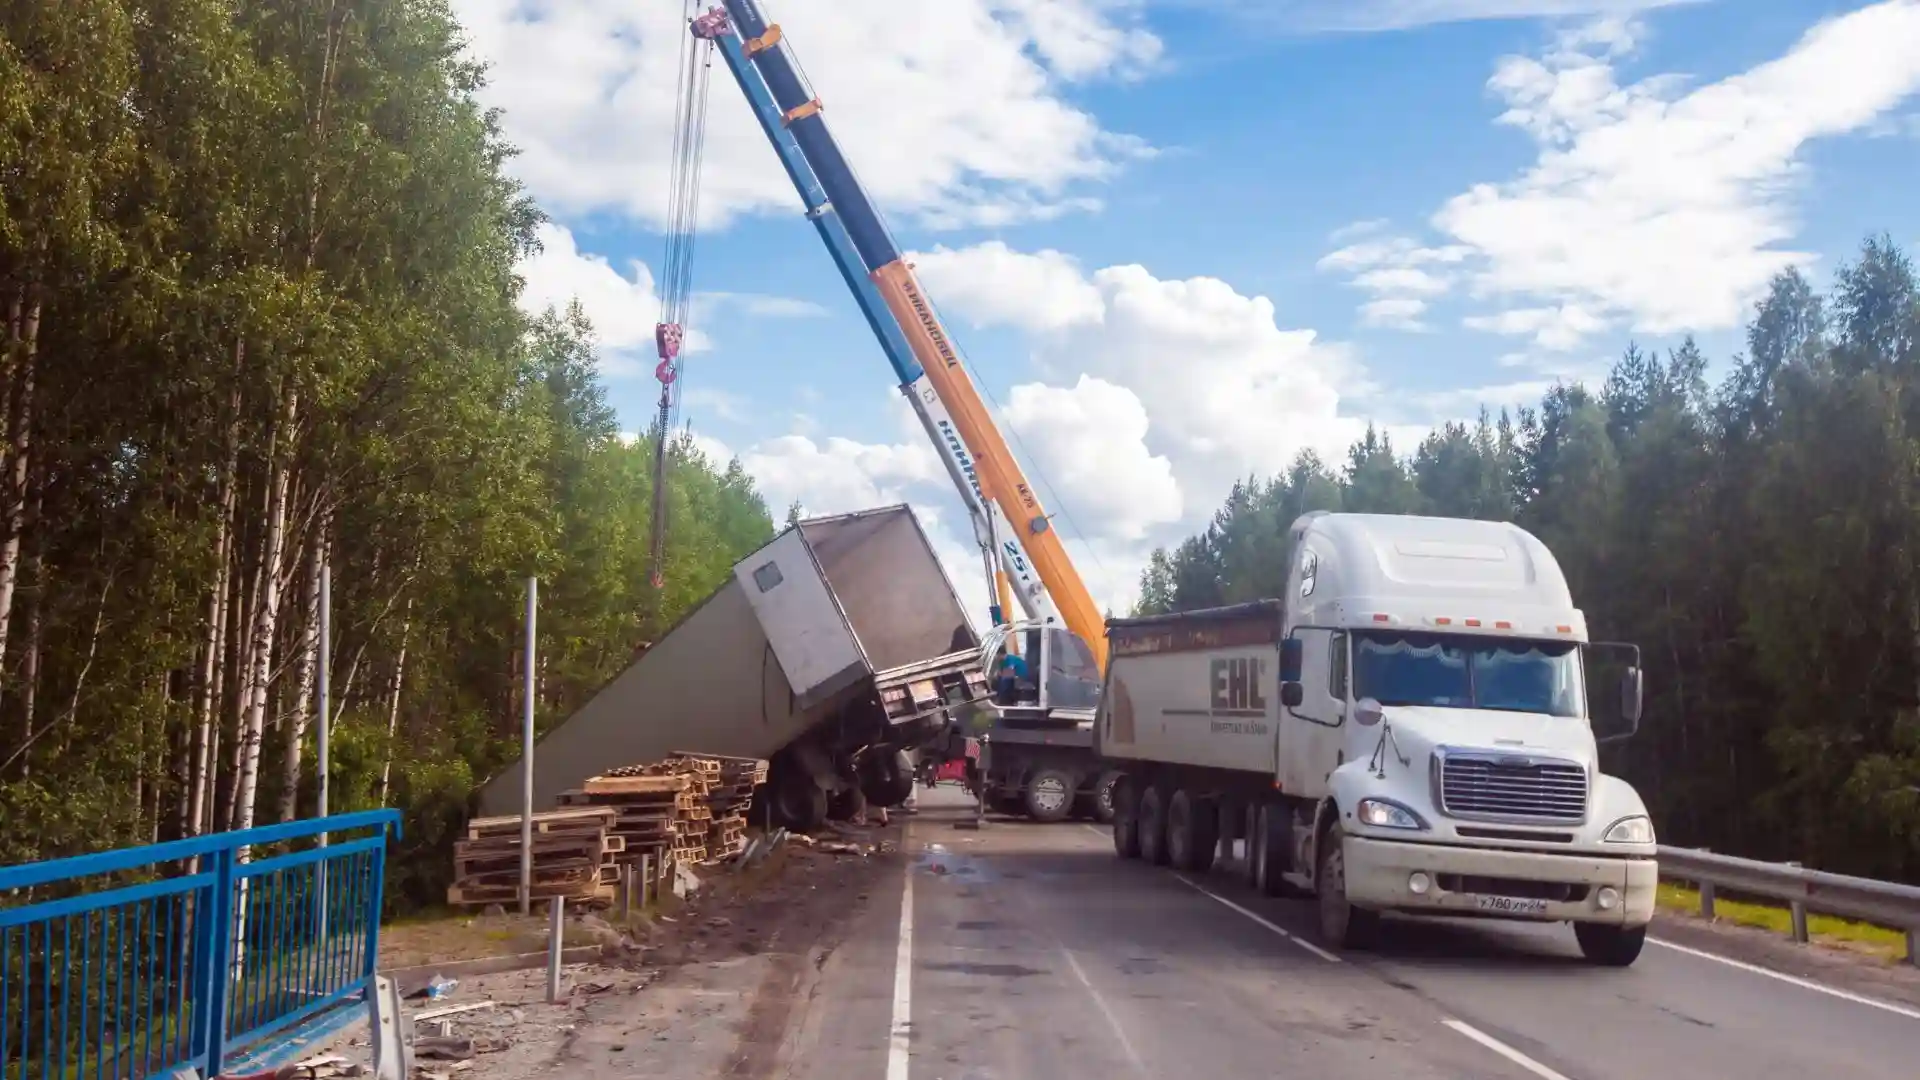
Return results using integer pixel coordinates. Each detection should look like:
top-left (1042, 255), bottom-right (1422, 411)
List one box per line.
top-left (447, 807), bottom-right (626, 903)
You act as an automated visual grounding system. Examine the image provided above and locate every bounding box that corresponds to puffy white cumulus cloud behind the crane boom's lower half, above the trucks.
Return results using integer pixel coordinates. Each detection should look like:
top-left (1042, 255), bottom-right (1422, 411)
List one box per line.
top-left (743, 242), bottom-right (1397, 611)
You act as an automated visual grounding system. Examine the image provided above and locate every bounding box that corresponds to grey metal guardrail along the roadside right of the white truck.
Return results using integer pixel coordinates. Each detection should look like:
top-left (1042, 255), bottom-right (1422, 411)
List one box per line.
top-left (1659, 846), bottom-right (1920, 967)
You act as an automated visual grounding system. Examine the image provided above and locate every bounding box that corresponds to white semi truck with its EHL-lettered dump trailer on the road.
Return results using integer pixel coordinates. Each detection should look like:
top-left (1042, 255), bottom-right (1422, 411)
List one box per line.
top-left (1094, 513), bottom-right (1657, 967)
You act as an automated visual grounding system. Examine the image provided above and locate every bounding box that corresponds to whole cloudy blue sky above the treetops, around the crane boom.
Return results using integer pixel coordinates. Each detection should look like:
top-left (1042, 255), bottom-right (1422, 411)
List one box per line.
top-left (455, 0), bottom-right (1920, 607)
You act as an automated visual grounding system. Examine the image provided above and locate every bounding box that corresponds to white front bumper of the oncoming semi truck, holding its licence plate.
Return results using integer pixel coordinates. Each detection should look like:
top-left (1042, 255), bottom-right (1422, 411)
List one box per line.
top-left (1342, 836), bottom-right (1659, 926)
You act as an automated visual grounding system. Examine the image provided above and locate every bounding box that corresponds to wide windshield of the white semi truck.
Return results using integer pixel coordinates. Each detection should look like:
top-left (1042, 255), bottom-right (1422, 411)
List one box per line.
top-left (1354, 630), bottom-right (1586, 717)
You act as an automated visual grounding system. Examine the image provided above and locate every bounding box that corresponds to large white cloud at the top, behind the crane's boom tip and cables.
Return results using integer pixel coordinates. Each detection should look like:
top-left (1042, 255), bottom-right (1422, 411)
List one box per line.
top-left (453, 0), bottom-right (1160, 227)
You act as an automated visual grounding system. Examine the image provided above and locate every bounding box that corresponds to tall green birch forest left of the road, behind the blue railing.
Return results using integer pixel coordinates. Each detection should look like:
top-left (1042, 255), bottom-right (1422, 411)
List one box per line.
top-left (0, 0), bottom-right (772, 903)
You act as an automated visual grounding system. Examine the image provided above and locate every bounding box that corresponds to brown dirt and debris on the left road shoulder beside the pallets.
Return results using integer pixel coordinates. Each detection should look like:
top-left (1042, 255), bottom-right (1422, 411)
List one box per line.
top-left (353, 822), bottom-right (900, 1080)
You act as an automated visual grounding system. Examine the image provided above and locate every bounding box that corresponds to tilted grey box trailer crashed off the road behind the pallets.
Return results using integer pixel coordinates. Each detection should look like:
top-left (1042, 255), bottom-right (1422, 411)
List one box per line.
top-left (480, 505), bottom-right (987, 828)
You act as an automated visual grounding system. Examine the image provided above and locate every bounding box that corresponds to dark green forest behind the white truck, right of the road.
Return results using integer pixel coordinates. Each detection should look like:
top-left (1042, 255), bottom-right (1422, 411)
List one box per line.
top-left (1139, 238), bottom-right (1920, 882)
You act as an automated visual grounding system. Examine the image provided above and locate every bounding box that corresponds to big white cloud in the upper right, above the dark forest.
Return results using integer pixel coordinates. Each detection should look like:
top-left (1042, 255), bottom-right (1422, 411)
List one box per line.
top-left (1321, 0), bottom-right (1920, 350)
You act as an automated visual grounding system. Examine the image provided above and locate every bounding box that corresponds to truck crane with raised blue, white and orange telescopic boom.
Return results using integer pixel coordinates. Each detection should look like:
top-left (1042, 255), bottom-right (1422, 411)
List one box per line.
top-left (691, 0), bottom-right (1117, 821)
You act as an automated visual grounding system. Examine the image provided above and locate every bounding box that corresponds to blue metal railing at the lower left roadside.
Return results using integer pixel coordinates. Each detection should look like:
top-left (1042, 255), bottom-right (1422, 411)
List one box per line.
top-left (0, 811), bottom-right (399, 1080)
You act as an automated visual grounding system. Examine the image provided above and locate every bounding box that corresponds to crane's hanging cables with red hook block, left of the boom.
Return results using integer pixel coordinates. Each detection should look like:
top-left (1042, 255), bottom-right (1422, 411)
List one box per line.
top-left (649, 0), bottom-right (714, 590)
